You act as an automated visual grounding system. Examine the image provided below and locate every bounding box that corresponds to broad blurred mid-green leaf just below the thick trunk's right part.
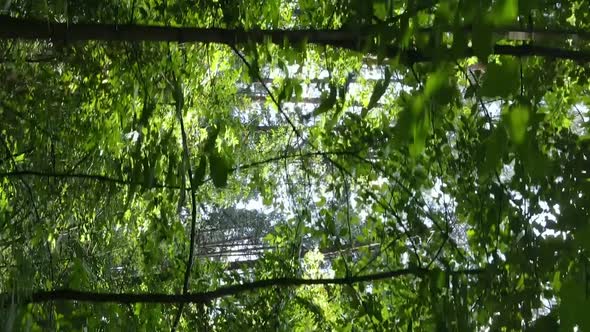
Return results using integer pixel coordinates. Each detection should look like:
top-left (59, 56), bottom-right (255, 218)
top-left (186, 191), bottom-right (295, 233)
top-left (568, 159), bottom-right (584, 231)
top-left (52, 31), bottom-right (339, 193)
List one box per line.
top-left (479, 58), bottom-right (520, 98)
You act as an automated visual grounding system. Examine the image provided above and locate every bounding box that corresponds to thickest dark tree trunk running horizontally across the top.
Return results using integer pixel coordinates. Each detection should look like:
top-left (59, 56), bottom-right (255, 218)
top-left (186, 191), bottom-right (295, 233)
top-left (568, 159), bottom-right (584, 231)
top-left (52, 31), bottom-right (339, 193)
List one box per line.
top-left (0, 15), bottom-right (590, 64)
